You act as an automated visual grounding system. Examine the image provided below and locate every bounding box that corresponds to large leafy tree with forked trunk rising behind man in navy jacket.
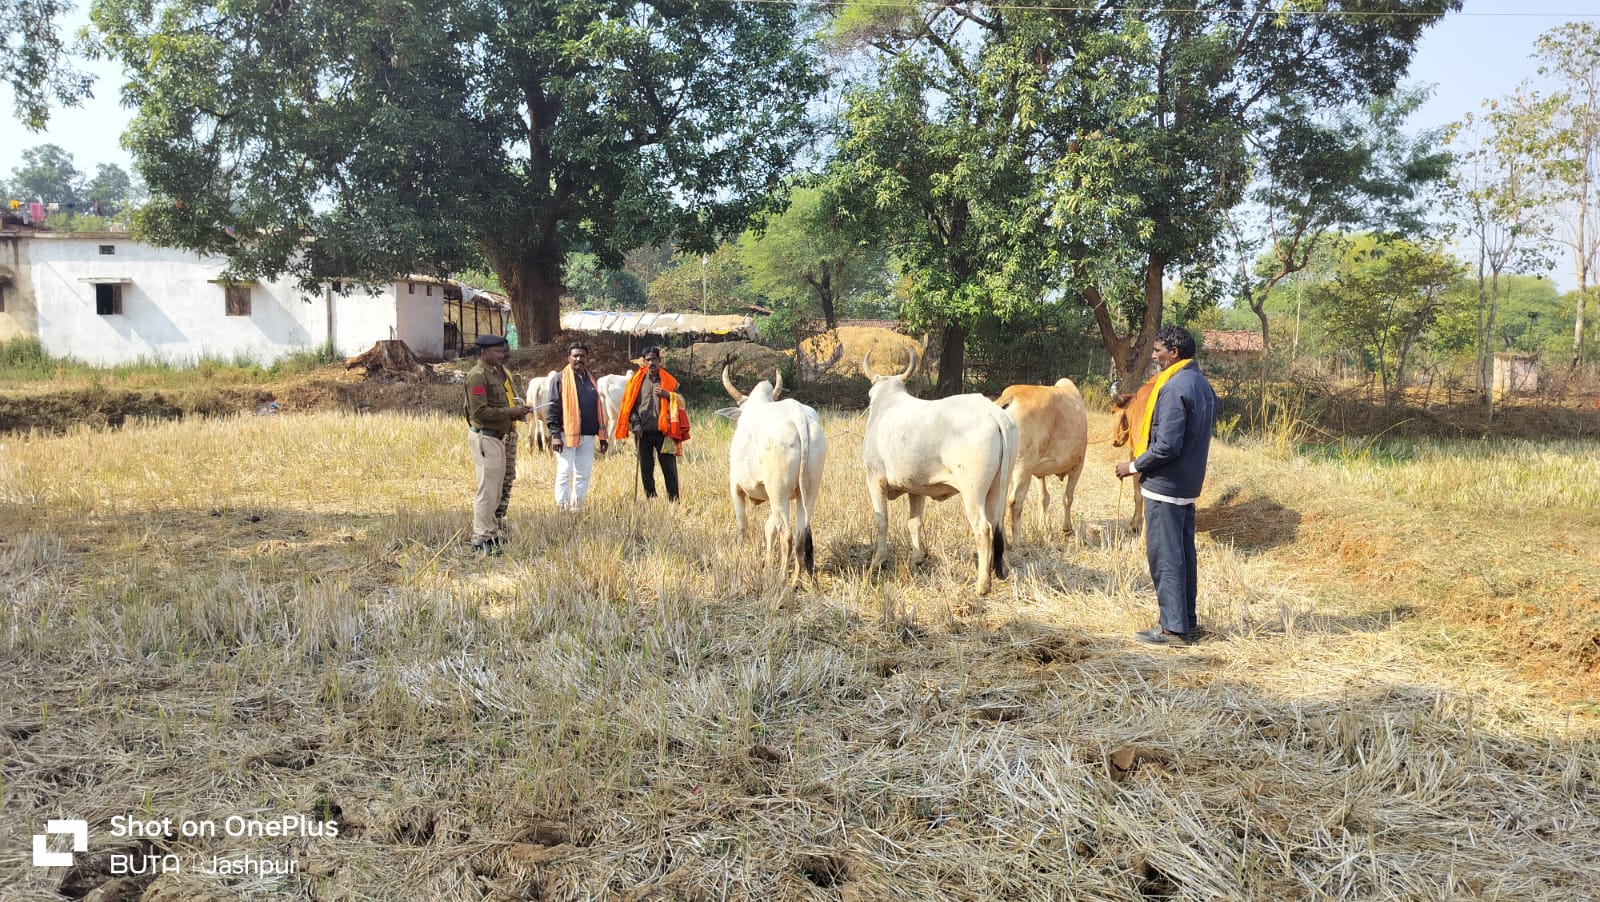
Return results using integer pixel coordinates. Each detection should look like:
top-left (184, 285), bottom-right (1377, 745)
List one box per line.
top-left (1053, 0), bottom-right (1461, 377)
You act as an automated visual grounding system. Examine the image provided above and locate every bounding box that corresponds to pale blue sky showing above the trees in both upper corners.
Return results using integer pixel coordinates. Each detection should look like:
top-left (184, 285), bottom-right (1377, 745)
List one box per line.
top-left (0, 0), bottom-right (1600, 281)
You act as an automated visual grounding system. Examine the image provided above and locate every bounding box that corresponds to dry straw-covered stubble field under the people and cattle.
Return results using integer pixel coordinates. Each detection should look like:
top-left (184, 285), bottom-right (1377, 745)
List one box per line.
top-left (0, 403), bottom-right (1600, 902)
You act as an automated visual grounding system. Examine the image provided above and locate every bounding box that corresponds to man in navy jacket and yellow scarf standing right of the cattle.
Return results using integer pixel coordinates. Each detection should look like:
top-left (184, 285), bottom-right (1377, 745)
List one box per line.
top-left (1117, 326), bottom-right (1216, 645)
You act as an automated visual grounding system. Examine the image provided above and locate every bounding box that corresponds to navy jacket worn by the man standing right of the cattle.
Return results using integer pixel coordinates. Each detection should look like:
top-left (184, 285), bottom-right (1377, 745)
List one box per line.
top-left (1133, 360), bottom-right (1216, 497)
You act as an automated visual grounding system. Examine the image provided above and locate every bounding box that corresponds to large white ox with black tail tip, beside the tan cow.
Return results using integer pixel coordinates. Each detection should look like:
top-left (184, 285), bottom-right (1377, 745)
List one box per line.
top-left (861, 352), bottom-right (1019, 595)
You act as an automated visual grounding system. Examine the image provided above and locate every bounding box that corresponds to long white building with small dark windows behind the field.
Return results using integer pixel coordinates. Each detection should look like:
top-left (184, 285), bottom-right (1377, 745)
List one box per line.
top-left (0, 224), bottom-right (480, 366)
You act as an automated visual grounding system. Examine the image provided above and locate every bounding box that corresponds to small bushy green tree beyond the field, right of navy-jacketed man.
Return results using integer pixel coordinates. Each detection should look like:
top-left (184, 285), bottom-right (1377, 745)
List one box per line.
top-left (1306, 235), bottom-right (1462, 401)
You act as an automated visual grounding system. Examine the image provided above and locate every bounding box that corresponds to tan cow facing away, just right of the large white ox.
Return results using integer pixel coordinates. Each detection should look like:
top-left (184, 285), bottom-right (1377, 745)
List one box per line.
top-left (995, 379), bottom-right (1090, 542)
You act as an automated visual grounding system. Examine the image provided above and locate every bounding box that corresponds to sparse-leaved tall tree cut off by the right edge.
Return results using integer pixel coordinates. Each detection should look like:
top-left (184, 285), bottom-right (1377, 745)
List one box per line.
top-left (1525, 22), bottom-right (1600, 366)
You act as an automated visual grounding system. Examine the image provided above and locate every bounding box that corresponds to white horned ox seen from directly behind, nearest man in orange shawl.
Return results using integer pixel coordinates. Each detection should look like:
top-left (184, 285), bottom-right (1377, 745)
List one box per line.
top-left (722, 366), bottom-right (827, 579)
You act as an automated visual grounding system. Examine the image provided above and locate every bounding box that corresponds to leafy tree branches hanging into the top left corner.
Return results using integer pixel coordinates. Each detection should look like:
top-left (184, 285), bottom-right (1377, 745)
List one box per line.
top-left (0, 0), bottom-right (93, 131)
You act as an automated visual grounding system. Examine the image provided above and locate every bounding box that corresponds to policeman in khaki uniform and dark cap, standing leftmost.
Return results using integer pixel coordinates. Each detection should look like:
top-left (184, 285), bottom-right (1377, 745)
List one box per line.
top-left (466, 336), bottom-right (531, 555)
